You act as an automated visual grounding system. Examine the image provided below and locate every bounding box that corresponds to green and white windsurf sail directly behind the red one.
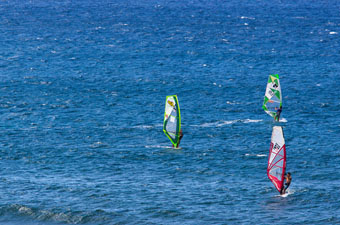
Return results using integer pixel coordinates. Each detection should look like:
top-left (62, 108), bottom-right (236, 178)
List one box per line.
top-left (262, 74), bottom-right (282, 118)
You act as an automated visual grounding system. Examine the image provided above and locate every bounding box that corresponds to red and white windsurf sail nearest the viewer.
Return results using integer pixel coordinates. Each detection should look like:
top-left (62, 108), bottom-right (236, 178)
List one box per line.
top-left (267, 126), bottom-right (286, 192)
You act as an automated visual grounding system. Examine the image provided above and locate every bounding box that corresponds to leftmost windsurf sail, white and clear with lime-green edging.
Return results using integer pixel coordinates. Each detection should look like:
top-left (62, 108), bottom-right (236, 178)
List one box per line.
top-left (163, 95), bottom-right (181, 148)
